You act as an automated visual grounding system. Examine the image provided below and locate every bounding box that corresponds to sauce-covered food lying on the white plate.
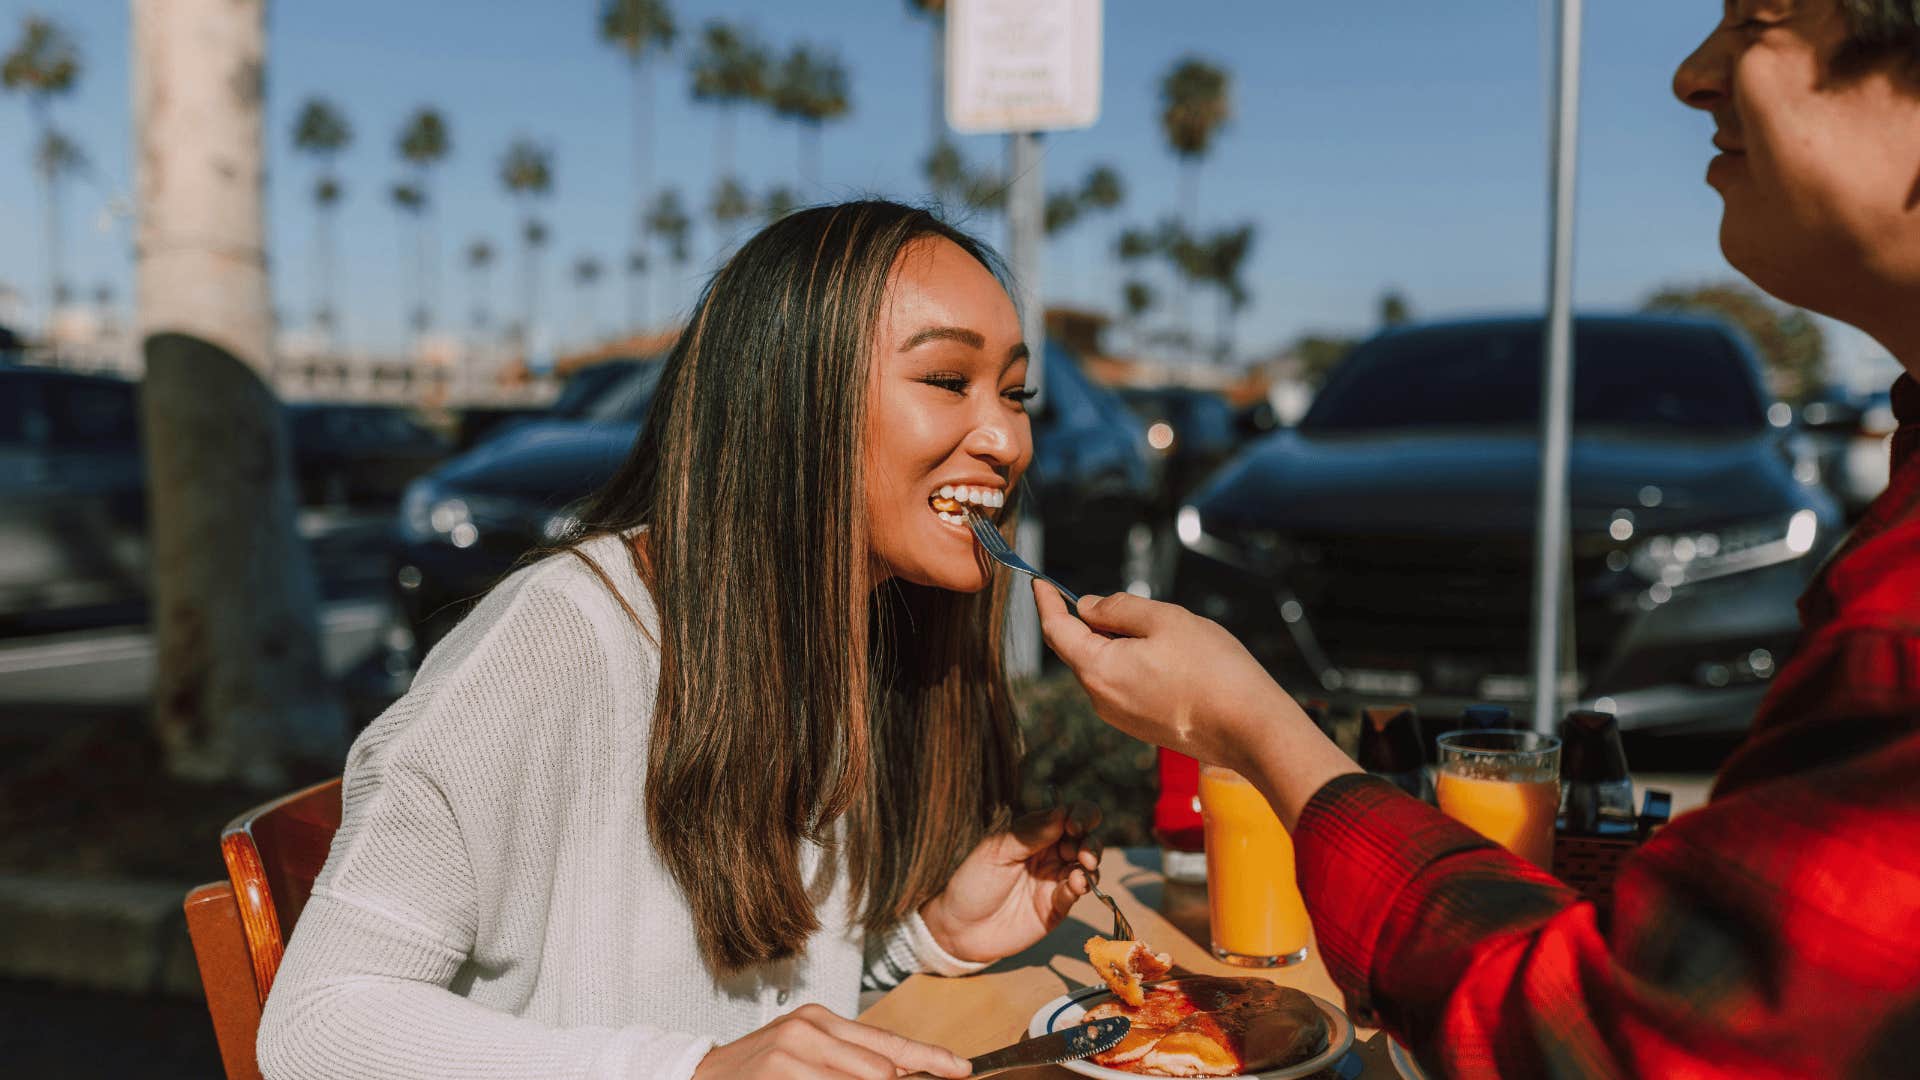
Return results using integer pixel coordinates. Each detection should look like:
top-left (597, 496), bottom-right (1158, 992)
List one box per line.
top-left (1081, 974), bottom-right (1331, 1076)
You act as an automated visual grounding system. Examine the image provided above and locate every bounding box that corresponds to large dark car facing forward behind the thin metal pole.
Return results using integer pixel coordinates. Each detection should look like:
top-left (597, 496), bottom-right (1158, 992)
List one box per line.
top-left (1175, 317), bottom-right (1841, 732)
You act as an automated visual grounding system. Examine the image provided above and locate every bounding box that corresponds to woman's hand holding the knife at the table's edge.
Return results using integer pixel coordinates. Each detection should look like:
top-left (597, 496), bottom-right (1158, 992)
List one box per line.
top-left (693, 1005), bottom-right (973, 1080)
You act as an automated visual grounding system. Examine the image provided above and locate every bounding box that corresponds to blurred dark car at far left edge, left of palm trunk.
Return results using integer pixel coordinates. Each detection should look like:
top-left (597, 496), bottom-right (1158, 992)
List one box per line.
top-left (0, 365), bottom-right (146, 636)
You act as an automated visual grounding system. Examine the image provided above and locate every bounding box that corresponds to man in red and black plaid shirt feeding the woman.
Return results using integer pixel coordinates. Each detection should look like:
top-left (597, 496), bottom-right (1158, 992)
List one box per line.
top-left (1035, 0), bottom-right (1920, 1076)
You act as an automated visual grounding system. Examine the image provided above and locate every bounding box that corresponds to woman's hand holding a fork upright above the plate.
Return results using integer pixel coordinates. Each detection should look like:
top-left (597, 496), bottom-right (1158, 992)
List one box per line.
top-left (920, 803), bottom-right (1100, 963)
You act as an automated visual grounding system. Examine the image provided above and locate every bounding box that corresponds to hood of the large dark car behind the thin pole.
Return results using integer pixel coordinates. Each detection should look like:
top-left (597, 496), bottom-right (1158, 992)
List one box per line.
top-left (1192, 430), bottom-right (1814, 534)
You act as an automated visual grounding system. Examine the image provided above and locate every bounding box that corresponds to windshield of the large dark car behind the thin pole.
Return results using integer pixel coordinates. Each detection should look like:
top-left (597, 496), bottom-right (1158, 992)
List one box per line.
top-left (1300, 323), bottom-right (1766, 432)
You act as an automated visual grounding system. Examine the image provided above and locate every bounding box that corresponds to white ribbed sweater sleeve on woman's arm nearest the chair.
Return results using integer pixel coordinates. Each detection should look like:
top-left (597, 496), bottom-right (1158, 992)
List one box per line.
top-left (255, 584), bottom-right (714, 1080)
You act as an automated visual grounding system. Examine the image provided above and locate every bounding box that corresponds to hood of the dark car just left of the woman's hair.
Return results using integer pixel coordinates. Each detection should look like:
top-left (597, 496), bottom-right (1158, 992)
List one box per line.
top-left (432, 421), bottom-right (639, 505)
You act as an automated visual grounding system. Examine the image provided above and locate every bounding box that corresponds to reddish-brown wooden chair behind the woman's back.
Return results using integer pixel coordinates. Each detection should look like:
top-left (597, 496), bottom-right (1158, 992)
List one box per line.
top-left (186, 778), bottom-right (340, 1080)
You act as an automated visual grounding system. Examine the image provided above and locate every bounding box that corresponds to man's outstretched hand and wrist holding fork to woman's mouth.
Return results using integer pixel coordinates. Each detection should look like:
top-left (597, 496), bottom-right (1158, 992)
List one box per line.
top-left (1033, 580), bottom-right (1359, 828)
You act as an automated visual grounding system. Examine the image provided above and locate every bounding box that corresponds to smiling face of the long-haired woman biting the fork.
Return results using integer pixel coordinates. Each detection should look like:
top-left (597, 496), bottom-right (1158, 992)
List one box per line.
top-left (866, 238), bottom-right (1033, 592)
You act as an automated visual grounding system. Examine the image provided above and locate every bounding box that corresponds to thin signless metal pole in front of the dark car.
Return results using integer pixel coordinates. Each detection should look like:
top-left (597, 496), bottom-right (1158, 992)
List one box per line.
top-left (1534, 0), bottom-right (1582, 732)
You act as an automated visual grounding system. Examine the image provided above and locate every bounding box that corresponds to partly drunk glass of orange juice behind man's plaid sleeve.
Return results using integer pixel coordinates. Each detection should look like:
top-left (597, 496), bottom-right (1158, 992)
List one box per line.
top-left (1436, 728), bottom-right (1559, 871)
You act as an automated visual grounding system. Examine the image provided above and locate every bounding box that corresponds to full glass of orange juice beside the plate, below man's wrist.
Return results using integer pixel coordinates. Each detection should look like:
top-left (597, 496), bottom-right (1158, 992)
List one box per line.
top-left (1200, 765), bottom-right (1313, 967)
